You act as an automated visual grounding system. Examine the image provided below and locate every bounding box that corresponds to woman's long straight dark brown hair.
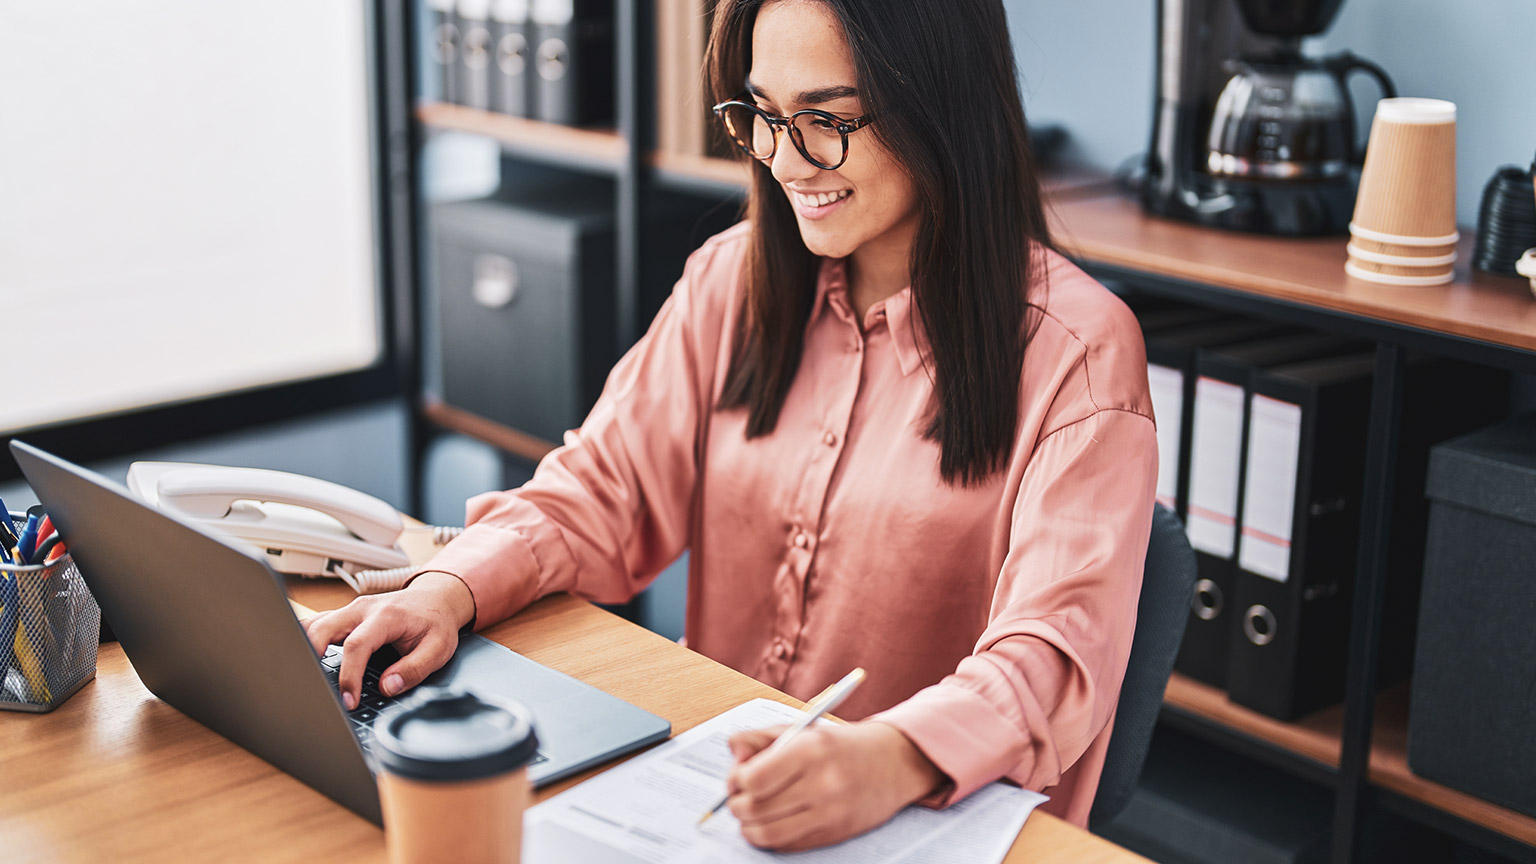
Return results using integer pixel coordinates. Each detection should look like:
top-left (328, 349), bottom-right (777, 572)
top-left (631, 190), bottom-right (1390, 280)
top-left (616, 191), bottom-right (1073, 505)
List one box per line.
top-left (708, 0), bottom-right (1049, 484)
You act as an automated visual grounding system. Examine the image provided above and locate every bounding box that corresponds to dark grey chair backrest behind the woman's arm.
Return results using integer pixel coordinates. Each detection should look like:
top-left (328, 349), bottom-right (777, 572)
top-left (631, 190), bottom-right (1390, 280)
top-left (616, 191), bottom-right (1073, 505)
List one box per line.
top-left (1087, 504), bottom-right (1195, 827)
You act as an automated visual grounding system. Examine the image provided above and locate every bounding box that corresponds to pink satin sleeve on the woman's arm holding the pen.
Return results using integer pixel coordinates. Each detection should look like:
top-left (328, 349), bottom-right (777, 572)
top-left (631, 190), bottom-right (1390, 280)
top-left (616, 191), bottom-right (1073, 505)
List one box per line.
top-left (871, 409), bottom-right (1157, 806)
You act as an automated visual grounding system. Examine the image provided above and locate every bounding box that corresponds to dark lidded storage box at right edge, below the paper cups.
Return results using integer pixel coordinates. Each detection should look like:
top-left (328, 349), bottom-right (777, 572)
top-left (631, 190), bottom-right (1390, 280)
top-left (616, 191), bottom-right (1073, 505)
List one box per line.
top-left (1409, 415), bottom-right (1536, 815)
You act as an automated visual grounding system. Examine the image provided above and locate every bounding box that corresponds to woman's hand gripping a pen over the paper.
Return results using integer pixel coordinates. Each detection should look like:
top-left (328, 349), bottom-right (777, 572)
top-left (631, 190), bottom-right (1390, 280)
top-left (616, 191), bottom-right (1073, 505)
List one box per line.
top-left (727, 723), bottom-right (946, 852)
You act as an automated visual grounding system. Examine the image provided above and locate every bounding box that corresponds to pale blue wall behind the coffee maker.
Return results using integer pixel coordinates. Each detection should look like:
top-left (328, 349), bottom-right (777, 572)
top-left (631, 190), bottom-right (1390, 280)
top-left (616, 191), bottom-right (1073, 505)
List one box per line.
top-left (1005, 0), bottom-right (1536, 224)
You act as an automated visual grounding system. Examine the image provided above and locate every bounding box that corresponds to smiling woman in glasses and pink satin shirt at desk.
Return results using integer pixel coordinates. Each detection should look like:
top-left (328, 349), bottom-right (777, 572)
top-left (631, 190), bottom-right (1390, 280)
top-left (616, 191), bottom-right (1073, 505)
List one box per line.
top-left (307, 0), bottom-right (1157, 849)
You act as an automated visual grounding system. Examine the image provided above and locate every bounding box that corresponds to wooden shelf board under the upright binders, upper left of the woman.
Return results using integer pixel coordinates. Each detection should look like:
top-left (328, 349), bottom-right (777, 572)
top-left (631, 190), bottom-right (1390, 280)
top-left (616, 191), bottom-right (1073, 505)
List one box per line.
top-left (416, 101), bottom-right (627, 172)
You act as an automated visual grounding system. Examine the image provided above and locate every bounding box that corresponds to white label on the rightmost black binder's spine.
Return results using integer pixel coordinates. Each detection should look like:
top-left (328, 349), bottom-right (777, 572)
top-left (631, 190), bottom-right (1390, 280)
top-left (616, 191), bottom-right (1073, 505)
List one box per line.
top-left (1238, 395), bottom-right (1301, 583)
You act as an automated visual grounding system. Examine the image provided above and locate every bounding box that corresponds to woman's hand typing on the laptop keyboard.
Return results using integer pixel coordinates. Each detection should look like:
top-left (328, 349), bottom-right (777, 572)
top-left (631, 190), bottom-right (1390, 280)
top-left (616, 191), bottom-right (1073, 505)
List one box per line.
top-left (301, 570), bottom-right (475, 710)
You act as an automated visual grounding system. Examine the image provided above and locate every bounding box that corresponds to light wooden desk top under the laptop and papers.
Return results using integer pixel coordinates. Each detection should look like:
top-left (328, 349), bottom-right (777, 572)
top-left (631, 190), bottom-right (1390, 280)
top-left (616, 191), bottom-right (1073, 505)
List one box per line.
top-left (0, 580), bottom-right (1143, 864)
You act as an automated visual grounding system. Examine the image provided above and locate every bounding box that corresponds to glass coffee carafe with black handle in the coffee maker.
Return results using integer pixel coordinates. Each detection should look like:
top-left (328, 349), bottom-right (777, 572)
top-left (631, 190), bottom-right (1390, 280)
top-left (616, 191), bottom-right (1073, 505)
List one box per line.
top-left (1207, 52), bottom-right (1396, 181)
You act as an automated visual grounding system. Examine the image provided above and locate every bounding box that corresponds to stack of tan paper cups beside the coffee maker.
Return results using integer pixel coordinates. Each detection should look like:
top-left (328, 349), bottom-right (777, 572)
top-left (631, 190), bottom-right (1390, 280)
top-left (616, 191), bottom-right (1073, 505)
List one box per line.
top-left (1344, 98), bottom-right (1461, 284)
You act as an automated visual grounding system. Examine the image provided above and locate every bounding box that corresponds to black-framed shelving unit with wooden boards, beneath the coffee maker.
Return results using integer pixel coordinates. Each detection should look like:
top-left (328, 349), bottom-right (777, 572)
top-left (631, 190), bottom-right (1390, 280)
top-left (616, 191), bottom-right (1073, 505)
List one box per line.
top-left (1051, 194), bottom-right (1536, 862)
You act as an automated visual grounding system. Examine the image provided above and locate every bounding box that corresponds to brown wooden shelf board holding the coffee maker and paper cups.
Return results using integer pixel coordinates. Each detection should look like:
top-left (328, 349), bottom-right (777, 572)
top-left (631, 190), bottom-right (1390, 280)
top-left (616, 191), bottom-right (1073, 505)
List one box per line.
top-left (1049, 194), bottom-right (1536, 351)
